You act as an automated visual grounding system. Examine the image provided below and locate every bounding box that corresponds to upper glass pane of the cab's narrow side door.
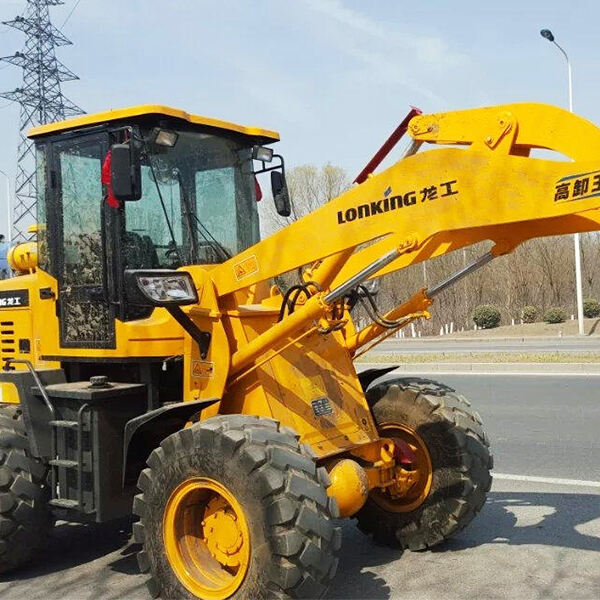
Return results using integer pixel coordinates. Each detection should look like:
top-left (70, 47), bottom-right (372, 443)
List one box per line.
top-left (58, 140), bottom-right (102, 285)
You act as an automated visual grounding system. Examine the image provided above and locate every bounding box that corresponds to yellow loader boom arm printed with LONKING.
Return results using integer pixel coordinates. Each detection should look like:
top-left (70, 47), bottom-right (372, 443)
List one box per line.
top-left (211, 104), bottom-right (600, 296)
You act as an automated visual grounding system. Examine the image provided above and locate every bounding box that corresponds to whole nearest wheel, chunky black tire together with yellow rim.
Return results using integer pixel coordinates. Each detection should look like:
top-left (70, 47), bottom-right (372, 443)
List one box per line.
top-left (134, 415), bottom-right (341, 600)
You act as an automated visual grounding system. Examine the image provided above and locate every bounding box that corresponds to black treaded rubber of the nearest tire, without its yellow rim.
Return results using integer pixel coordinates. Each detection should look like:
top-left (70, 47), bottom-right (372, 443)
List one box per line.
top-left (133, 415), bottom-right (341, 600)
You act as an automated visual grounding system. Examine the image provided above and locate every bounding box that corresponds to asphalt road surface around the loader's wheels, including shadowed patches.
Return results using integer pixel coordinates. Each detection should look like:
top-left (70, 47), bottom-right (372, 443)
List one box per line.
top-left (0, 374), bottom-right (600, 600)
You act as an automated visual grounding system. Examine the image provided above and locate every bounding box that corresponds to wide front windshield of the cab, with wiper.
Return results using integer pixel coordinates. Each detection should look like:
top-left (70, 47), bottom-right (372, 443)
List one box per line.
top-left (124, 130), bottom-right (259, 269)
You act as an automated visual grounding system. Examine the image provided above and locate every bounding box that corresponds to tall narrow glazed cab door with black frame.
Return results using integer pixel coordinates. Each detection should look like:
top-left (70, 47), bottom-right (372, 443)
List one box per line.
top-left (52, 133), bottom-right (118, 348)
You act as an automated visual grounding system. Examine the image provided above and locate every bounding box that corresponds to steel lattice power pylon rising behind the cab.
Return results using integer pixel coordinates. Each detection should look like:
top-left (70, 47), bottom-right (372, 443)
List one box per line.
top-left (0, 0), bottom-right (84, 241)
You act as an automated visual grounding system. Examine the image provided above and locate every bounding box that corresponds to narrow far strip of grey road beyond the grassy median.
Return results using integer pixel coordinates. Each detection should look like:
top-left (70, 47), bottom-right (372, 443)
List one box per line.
top-left (370, 336), bottom-right (600, 354)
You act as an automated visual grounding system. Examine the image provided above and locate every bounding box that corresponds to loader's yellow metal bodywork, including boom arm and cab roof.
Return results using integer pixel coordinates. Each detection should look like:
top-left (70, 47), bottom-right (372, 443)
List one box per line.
top-left (0, 104), bottom-right (600, 510)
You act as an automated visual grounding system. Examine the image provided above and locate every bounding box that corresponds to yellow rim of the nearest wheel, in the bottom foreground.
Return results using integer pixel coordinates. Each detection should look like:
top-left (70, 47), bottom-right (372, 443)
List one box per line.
top-left (163, 477), bottom-right (250, 600)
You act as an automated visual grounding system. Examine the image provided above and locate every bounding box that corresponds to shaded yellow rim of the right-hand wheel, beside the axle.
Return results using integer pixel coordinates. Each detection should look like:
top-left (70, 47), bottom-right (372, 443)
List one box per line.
top-left (371, 423), bottom-right (433, 512)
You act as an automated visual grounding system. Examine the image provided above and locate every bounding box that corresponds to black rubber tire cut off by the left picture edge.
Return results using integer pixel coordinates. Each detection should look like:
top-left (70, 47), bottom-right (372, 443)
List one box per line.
top-left (0, 404), bottom-right (53, 573)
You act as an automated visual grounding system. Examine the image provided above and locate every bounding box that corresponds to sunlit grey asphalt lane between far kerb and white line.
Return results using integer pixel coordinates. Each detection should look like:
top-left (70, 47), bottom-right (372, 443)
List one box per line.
top-left (380, 373), bottom-right (600, 480)
